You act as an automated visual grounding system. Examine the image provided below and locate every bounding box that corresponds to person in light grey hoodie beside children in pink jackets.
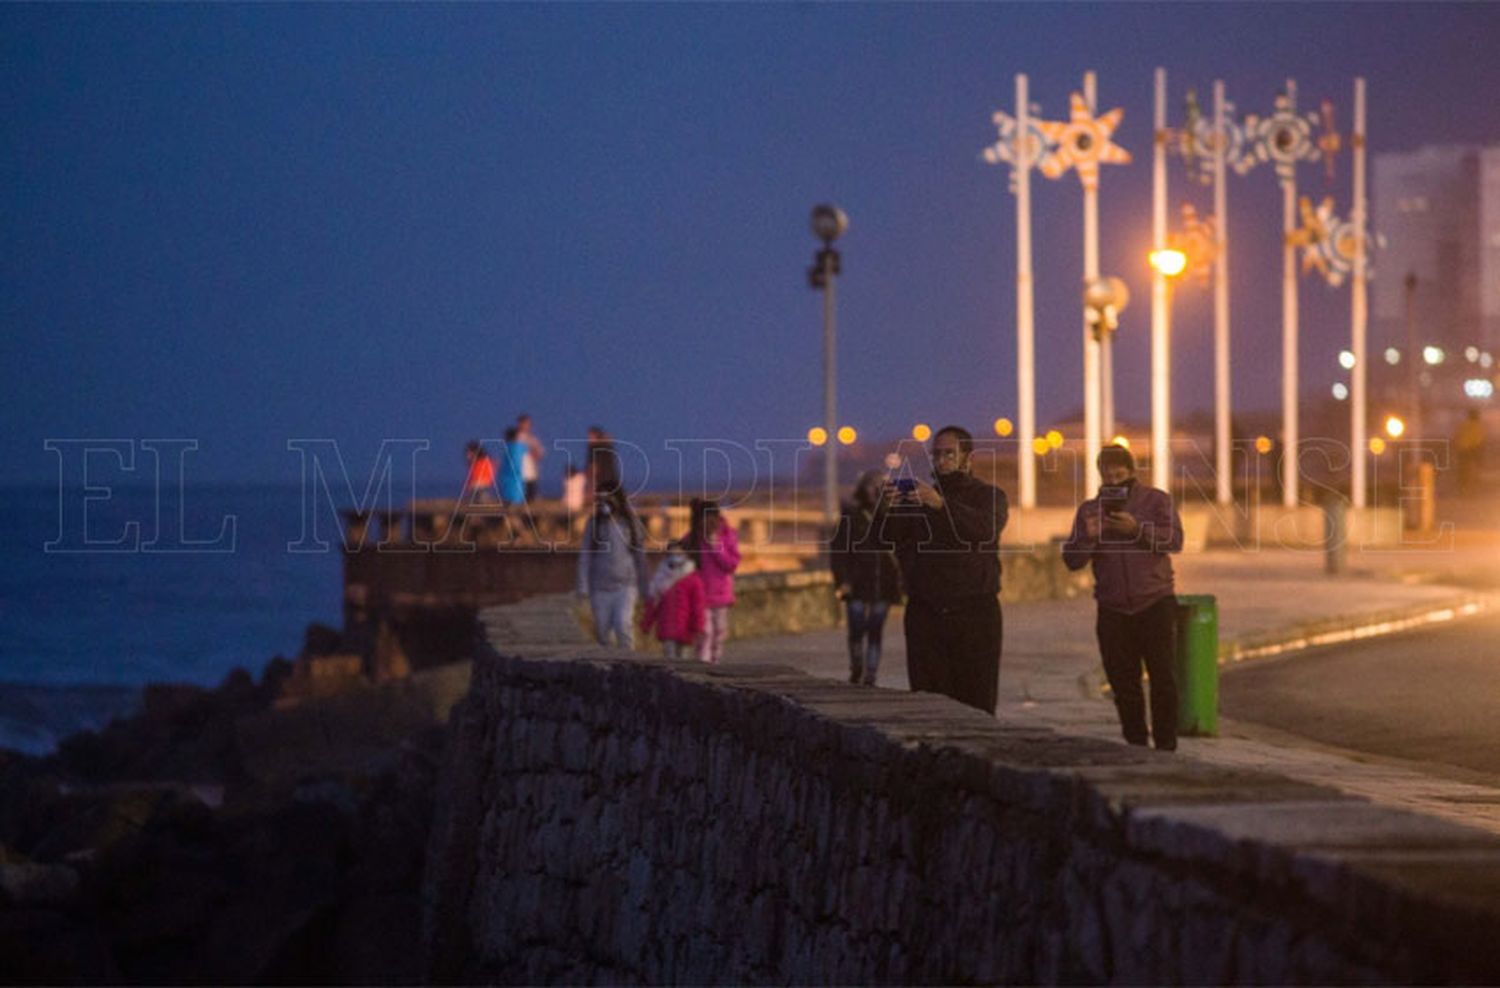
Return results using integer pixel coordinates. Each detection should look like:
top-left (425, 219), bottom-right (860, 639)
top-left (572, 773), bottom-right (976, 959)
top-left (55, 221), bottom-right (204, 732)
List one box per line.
top-left (578, 487), bottom-right (647, 649)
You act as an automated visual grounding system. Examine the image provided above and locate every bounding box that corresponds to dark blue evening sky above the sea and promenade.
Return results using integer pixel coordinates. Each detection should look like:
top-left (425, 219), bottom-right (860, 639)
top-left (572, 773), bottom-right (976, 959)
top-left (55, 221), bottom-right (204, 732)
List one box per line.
top-left (0, 4), bottom-right (1500, 483)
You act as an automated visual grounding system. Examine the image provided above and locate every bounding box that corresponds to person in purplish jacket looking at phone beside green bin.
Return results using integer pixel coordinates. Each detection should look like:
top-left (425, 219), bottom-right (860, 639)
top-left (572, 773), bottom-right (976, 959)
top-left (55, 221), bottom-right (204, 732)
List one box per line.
top-left (1062, 445), bottom-right (1182, 751)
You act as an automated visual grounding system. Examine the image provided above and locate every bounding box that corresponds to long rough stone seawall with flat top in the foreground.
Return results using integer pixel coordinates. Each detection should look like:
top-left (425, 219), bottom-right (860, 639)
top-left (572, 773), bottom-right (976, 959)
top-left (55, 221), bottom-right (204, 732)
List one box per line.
top-left (425, 648), bottom-right (1500, 984)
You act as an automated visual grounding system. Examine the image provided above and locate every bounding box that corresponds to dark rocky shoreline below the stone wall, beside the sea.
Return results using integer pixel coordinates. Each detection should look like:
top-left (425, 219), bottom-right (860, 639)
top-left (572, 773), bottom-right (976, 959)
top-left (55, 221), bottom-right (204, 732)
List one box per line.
top-left (0, 625), bottom-right (468, 984)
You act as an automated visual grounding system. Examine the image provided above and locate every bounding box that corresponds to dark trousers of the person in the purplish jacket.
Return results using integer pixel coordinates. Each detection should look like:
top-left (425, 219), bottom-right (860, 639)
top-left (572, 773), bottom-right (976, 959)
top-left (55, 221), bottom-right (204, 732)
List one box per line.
top-left (1097, 594), bottom-right (1178, 751)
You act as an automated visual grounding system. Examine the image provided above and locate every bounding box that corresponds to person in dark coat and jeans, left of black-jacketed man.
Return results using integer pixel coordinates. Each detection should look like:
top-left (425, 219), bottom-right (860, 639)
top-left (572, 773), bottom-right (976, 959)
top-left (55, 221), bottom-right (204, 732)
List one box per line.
top-left (828, 471), bottom-right (902, 687)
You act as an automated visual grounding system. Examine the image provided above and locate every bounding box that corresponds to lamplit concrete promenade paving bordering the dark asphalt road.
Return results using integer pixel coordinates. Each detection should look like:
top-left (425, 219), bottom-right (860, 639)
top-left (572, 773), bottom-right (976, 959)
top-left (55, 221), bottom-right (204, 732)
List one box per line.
top-left (726, 546), bottom-right (1500, 834)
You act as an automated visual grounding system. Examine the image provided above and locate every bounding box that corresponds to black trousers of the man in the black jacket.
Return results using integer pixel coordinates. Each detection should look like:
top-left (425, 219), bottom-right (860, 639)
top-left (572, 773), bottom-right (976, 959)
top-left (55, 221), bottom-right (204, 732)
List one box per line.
top-left (906, 595), bottom-right (1005, 714)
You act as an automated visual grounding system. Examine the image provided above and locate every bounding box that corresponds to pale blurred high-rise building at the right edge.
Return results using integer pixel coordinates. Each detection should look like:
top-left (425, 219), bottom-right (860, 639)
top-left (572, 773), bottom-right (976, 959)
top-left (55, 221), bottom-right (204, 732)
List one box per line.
top-left (1371, 145), bottom-right (1500, 355)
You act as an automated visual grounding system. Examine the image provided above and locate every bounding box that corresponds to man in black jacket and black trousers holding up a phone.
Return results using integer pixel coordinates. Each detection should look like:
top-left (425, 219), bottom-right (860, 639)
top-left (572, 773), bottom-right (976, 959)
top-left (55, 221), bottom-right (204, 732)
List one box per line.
top-left (879, 426), bottom-right (1010, 714)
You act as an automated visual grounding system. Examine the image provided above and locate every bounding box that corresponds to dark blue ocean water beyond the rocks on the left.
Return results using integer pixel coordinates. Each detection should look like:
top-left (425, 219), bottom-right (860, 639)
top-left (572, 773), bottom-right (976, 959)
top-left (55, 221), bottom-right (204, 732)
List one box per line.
top-left (0, 487), bottom-right (342, 753)
